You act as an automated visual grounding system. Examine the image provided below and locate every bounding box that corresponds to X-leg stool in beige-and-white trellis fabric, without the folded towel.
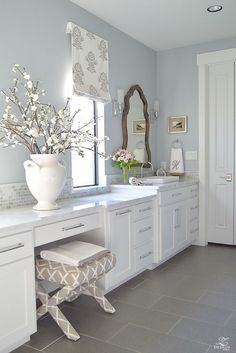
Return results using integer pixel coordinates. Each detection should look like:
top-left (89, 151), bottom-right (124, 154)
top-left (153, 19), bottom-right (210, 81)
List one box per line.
top-left (36, 246), bottom-right (116, 341)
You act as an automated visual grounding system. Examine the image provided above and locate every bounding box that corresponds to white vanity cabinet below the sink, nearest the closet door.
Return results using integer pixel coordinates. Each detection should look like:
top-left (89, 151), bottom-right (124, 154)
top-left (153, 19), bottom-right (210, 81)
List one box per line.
top-left (158, 185), bottom-right (198, 261)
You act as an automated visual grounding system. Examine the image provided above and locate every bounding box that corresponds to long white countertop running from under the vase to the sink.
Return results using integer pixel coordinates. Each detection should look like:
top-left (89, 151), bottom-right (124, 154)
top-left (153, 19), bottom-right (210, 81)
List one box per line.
top-left (0, 180), bottom-right (198, 237)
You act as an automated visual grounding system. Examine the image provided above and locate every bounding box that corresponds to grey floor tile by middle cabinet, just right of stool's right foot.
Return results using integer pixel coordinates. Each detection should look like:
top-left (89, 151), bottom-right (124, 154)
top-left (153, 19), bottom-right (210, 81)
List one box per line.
top-left (109, 286), bottom-right (160, 308)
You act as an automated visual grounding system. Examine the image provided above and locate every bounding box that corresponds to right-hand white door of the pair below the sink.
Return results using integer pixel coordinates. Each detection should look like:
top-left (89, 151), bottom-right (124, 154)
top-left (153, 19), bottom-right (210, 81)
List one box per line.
top-left (173, 201), bottom-right (188, 250)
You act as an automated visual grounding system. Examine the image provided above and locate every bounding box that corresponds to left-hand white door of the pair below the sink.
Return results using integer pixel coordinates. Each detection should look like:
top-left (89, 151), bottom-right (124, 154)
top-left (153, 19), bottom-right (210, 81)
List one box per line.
top-left (160, 205), bottom-right (175, 260)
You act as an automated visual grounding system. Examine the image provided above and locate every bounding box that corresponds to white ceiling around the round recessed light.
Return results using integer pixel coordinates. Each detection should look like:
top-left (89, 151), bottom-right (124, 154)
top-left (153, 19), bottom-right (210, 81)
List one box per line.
top-left (71, 0), bottom-right (236, 51)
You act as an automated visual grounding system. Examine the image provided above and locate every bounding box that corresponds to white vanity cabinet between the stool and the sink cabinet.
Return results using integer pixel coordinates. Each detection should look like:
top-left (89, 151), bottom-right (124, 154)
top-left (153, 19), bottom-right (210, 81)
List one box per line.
top-left (105, 199), bottom-right (154, 290)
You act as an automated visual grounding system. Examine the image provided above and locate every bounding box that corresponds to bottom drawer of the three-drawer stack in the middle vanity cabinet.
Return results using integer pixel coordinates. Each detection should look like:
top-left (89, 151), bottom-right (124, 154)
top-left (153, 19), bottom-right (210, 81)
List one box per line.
top-left (135, 242), bottom-right (153, 272)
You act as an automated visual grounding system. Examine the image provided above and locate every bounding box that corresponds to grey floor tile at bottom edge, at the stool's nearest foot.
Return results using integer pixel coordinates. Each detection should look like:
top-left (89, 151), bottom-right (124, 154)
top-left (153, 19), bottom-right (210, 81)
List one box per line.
top-left (43, 336), bottom-right (138, 353)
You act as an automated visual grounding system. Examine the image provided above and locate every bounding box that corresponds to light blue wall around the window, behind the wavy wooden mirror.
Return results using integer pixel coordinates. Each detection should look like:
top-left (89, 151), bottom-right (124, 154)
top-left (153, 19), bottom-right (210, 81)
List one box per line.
top-left (0, 0), bottom-right (159, 183)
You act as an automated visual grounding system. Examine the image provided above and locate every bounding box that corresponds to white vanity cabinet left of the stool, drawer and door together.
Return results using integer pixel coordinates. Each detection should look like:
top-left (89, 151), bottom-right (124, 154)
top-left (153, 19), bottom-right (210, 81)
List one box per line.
top-left (0, 231), bottom-right (36, 353)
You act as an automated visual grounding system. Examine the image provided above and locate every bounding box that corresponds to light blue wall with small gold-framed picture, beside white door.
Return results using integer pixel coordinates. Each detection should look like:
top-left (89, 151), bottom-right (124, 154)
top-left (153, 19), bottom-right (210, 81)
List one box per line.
top-left (157, 38), bottom-right (236, 171)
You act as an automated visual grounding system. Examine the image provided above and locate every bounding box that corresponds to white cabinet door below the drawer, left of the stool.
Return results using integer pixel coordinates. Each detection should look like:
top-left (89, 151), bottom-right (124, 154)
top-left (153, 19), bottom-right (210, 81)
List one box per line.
top-left (0, 257), bottom-right (36, 351)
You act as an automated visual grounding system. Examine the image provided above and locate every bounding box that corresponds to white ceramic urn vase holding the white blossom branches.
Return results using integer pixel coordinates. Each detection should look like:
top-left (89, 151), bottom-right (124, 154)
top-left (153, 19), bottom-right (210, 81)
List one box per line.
top-left (24, 154), bottom-right (66, 211)
